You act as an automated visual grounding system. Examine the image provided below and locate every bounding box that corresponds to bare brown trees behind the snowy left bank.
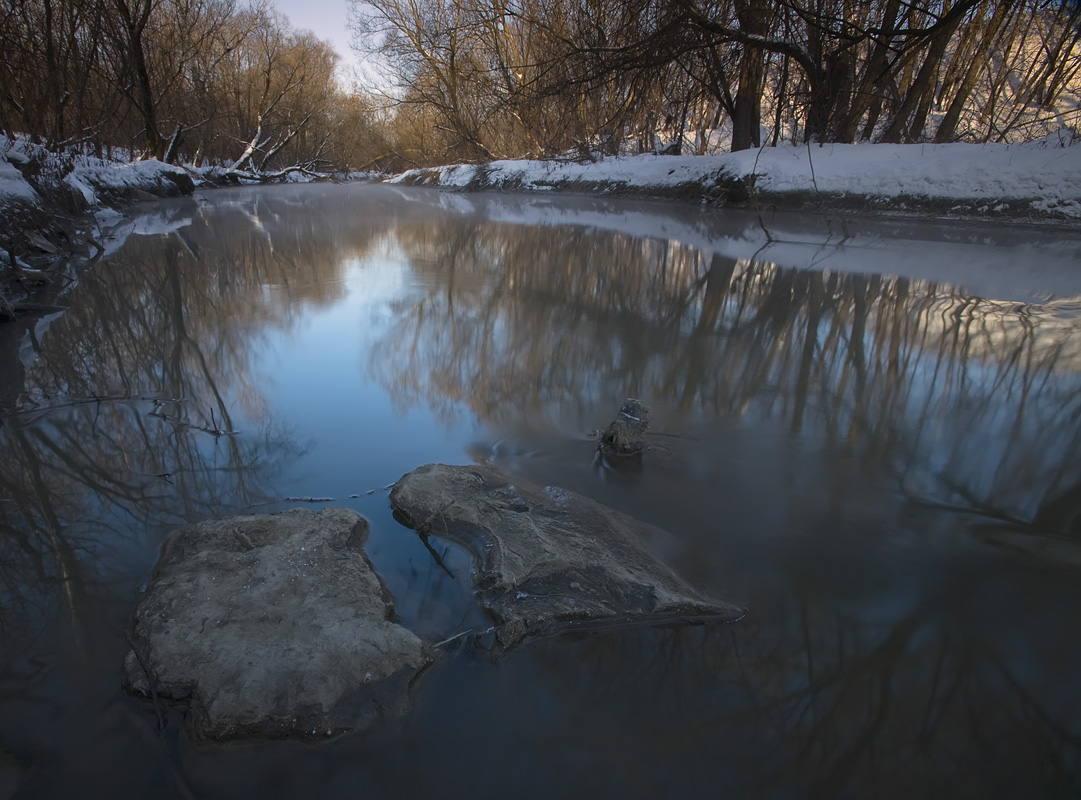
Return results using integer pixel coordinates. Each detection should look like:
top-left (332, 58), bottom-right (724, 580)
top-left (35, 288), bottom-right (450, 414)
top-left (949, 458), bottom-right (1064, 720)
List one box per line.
top-left (0, 0), bottom-right (389, 171)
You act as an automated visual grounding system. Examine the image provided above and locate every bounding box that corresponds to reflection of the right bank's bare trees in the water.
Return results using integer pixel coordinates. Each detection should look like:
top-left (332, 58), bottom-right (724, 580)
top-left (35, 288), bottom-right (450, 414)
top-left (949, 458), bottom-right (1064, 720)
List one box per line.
top-left (371, 209), bottom-right (1081, 534)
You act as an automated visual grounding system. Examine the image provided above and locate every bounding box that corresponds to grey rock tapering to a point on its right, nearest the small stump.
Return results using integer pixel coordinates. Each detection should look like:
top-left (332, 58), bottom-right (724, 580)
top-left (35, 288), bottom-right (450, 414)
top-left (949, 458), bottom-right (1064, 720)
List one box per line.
top-left (390, 464), bottom-right (745, 649)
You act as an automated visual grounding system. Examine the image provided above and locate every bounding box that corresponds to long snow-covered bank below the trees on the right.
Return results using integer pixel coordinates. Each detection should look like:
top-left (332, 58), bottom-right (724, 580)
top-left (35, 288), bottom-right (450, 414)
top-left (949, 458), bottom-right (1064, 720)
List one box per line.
top-left (391, 131), bottom-right (1081, 222)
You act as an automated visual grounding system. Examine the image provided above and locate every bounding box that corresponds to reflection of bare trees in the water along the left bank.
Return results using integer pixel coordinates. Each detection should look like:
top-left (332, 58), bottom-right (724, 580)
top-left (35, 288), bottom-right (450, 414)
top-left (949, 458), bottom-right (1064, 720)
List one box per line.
top-left (0, 189), bottom-right (389, 648)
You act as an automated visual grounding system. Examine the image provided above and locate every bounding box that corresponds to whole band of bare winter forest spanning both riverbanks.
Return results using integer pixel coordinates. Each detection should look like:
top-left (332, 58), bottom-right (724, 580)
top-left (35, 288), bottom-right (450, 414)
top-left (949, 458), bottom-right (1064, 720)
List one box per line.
top-left (0, 0), bottom-right (1081, 173)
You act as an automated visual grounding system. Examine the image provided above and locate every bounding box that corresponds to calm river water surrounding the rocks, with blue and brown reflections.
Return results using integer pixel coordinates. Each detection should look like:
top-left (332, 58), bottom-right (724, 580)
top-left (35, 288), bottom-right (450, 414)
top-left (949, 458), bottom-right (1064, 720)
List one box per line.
top-left (0, 185), bottom-right (1081, 800)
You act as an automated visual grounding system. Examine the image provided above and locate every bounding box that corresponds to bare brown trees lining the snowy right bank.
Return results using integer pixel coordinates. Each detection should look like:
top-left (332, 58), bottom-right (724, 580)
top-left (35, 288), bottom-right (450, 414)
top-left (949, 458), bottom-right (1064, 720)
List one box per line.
top-left (353, 0), bottom-right (1081, 160)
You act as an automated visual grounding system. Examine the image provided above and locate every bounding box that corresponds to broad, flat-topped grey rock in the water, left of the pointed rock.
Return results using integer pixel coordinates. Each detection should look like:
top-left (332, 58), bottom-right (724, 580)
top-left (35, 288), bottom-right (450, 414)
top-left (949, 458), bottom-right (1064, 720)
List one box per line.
top-left (124, 508), bottom-right (430, 738)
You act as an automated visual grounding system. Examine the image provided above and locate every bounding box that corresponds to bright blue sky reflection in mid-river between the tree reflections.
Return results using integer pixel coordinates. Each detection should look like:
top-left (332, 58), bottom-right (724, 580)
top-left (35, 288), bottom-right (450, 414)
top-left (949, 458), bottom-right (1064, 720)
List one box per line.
top-left (254, 253), bottom-right (479, 498)
